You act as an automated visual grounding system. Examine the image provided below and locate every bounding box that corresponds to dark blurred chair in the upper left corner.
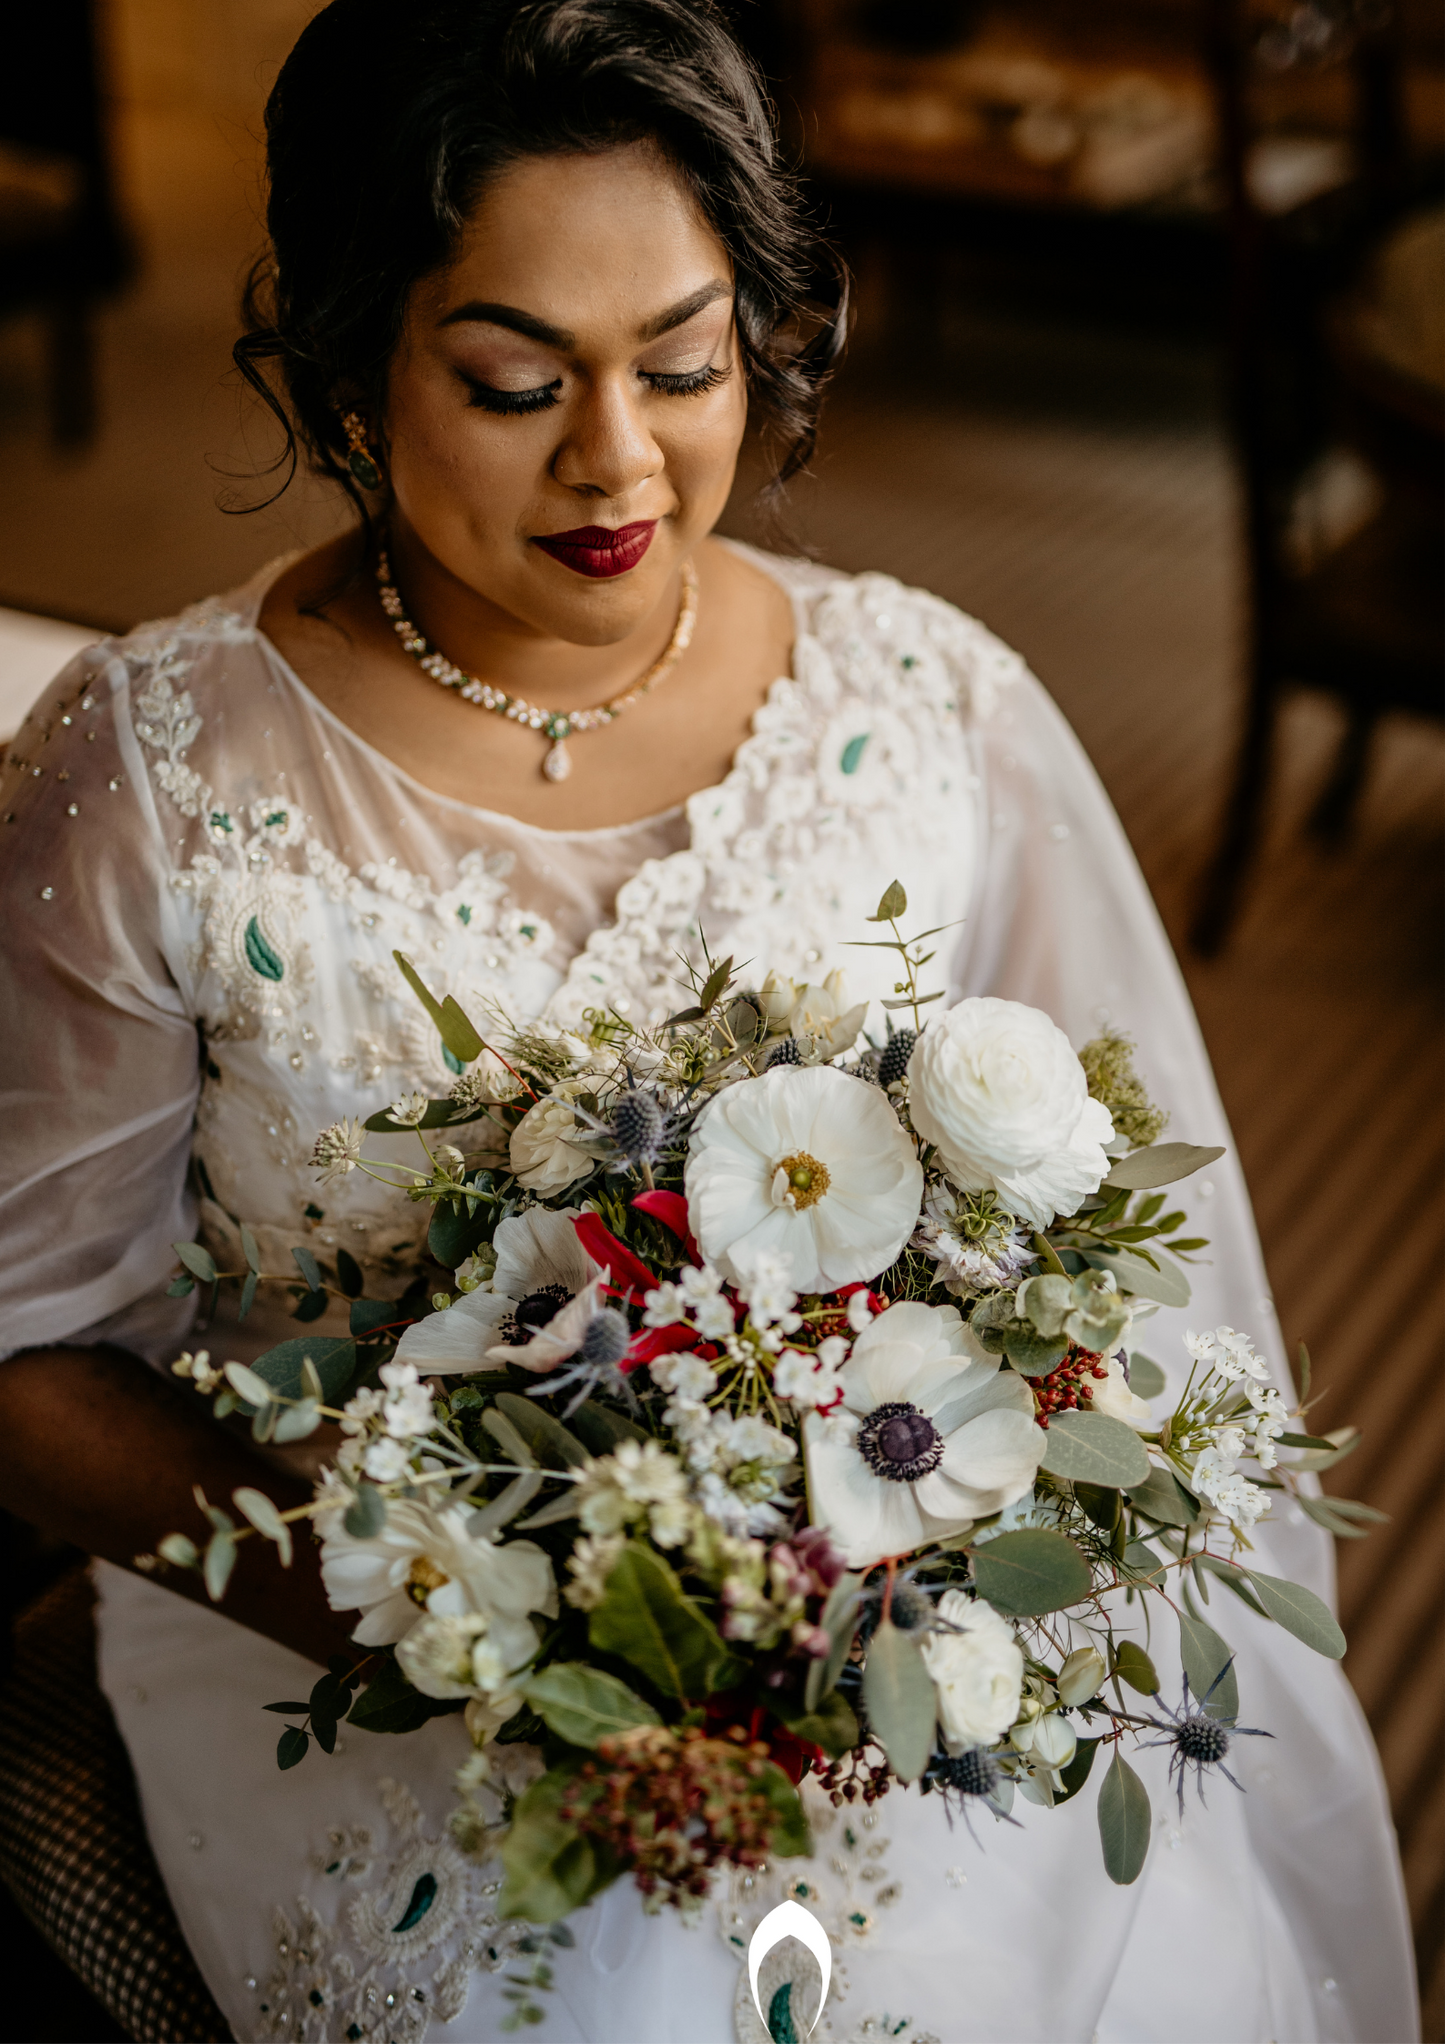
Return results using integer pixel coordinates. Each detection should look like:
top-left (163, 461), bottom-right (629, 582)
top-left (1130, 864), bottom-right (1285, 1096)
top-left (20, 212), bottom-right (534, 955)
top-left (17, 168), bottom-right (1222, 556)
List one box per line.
top-left (0, 0), bottom-right (131, 446)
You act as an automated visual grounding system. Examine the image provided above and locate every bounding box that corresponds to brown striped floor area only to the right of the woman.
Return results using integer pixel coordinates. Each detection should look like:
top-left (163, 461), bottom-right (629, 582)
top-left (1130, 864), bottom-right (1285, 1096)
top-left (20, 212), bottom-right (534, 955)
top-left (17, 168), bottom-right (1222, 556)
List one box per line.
top-left (735, 319), bottom-right (1445, 2040)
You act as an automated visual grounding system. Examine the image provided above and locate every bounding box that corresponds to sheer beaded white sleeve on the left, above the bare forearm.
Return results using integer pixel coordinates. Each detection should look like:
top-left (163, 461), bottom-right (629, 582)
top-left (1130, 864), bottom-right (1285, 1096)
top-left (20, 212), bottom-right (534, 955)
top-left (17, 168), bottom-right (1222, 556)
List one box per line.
top-left (0, 642), bottom-right (198, 1357)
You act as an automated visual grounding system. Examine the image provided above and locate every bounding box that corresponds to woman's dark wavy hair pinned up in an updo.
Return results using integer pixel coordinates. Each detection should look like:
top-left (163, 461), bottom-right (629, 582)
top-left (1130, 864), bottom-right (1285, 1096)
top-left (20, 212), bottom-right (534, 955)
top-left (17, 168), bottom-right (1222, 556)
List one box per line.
top-left (235, 0), bottom-right (846, 525)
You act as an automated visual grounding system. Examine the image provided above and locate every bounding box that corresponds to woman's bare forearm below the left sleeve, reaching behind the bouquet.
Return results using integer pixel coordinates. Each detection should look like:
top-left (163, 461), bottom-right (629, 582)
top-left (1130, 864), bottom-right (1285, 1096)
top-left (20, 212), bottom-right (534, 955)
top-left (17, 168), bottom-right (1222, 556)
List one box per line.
top-left (0, 1347), bottom-right (360, 1666)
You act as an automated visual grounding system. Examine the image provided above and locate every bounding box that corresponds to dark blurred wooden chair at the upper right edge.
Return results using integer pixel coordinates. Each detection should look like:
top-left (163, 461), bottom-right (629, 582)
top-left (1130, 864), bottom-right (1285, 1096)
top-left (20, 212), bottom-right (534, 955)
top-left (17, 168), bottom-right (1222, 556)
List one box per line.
top-left (1194, 0), bottom-right (1445, 953)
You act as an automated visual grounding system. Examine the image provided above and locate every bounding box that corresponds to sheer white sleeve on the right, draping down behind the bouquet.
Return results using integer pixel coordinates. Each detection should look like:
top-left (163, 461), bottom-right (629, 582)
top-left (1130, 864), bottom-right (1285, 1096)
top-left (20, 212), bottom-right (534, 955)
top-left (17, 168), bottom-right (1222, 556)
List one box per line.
top-left (950, 645), bottom-right (1333, 1598)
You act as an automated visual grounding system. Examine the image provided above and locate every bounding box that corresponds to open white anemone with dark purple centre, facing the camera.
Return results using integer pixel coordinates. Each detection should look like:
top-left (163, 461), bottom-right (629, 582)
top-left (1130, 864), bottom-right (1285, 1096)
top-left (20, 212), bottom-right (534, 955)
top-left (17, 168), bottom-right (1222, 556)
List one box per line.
top-left (803, 1302), bottom-right (1046, 1568)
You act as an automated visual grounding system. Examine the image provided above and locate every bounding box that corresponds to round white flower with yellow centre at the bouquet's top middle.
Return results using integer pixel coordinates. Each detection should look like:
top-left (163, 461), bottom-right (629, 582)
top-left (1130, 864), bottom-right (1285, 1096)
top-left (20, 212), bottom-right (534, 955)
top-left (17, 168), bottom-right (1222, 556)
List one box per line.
top-left (685, 1065), bottom-right (924, 1292)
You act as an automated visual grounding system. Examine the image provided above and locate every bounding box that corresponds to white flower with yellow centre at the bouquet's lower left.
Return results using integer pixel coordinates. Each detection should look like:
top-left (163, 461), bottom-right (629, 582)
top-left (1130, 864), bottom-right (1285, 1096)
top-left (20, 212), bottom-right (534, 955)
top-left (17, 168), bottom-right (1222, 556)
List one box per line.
top-left (321, 1498), bottom-right (558, 1647)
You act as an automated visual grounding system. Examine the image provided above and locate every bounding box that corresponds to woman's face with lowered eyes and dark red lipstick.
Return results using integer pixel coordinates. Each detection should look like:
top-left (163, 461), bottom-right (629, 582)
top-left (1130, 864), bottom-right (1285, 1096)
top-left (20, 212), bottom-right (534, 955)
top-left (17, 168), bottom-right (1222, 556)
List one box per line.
top-left (384, 143), bottom-right (746, 646)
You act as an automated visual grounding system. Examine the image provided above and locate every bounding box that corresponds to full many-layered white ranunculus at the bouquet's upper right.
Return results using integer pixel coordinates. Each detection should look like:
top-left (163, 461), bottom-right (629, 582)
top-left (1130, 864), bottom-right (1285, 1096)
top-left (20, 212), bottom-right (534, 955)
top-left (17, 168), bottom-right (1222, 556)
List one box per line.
top-left (907, 997), bottom-right (1114, 1228)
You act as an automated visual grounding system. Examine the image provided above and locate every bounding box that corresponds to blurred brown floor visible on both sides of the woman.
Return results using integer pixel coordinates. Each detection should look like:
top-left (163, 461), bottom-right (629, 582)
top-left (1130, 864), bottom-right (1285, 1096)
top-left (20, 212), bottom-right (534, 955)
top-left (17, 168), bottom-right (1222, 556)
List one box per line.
top-left (0, 103), bottom-right (1445, 2040)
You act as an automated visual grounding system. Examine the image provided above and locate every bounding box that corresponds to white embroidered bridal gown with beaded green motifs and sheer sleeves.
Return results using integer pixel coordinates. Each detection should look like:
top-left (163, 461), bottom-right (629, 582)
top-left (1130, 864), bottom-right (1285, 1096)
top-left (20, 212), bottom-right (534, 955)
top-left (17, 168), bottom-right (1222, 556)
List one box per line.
top-left (0, 556), bottom-right (1416, 2044)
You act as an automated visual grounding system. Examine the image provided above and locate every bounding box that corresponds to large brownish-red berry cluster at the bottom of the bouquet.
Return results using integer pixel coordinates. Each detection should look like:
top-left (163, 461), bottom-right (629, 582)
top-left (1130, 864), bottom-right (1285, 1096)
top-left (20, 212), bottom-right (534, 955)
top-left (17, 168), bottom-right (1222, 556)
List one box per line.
top-left (560, 1725), bottom-right (777, 1909)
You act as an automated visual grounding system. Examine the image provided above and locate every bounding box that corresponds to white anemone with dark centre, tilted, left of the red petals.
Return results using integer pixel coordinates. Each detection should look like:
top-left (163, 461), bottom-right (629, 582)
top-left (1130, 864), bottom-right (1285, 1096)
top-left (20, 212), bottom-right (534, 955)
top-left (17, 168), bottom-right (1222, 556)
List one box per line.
top-left (397, 1206), bottom-right (601, 1374)
